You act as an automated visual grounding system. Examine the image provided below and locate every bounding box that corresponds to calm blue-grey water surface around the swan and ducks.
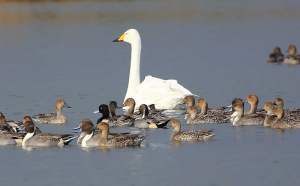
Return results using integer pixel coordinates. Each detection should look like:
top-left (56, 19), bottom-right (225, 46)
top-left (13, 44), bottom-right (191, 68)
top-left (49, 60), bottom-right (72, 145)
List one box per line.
top-left (0, 0), bottom-right (300, 186)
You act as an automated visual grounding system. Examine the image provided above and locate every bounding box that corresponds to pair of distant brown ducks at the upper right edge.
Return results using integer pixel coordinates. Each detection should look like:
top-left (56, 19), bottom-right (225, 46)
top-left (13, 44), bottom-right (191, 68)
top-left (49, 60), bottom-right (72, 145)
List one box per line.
top-left (267, 45), bottom-right (300, 65)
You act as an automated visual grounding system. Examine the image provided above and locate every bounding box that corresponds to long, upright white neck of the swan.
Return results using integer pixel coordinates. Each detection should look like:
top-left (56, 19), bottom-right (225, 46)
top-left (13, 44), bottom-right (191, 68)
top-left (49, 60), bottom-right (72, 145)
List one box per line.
top-left (124, 35), bottom-right (142, 102)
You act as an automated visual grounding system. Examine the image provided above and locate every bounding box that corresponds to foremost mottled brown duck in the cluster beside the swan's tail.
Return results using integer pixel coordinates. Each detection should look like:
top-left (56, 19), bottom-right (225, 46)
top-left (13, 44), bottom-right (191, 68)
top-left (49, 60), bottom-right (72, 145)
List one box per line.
top-left (187, 106), bottom-right (229, 124)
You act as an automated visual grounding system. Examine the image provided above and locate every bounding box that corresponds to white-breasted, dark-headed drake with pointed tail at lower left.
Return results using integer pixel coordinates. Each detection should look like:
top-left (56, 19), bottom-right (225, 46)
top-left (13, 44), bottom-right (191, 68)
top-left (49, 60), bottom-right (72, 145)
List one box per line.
top-left (22, 116), bottom-right (78, 147)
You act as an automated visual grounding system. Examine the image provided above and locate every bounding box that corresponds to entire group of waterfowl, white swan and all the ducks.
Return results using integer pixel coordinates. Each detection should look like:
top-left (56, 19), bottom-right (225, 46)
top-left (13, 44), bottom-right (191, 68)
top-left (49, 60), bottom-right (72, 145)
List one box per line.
top-left (0, 29), bottom-right (300, 150)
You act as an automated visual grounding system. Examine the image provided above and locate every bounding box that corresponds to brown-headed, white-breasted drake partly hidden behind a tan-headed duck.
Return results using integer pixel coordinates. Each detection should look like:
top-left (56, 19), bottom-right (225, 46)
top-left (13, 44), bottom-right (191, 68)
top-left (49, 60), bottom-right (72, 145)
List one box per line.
top-left (77, 118), bottom-right (129, 147)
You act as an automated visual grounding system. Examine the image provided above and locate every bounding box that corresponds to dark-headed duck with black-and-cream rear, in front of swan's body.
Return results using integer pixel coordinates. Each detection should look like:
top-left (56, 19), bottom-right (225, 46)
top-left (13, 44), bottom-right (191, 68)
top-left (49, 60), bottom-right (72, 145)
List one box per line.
top-left (134, 104), bottom-right (170, 129)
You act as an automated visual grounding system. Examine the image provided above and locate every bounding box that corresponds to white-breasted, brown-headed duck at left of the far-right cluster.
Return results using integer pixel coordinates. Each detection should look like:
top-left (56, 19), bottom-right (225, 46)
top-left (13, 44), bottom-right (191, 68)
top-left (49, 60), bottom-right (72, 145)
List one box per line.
top-left (231, 102), bottom-right (265, 126)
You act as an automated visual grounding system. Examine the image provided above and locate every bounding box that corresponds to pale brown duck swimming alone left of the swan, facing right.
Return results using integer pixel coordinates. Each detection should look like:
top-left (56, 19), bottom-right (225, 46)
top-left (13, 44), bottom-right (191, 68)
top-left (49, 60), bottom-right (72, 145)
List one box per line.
top-left (32, 99), bottom-right (71, 124)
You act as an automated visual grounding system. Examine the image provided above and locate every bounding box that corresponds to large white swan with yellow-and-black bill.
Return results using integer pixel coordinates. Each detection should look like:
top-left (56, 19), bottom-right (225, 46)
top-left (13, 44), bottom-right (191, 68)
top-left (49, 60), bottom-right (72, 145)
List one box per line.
top-left (113, 29), bottom-right (193, 109)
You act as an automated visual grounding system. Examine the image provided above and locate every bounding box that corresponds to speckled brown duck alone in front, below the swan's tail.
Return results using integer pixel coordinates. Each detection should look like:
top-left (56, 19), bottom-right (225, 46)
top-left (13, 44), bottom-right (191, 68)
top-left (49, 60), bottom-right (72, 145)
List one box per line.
top-left (170, 119), bottom-right (217, 141)
